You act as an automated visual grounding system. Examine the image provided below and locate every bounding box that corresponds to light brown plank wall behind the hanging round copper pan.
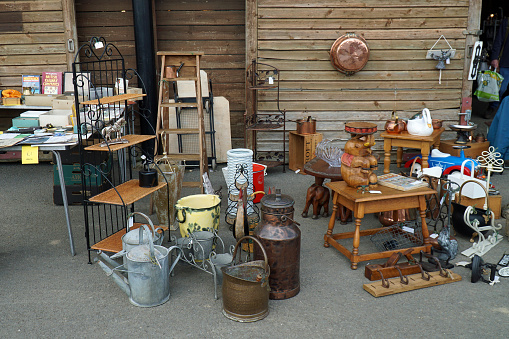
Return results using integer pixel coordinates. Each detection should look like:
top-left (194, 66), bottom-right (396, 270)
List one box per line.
top-left (257, 0), bottom-right (469, 150)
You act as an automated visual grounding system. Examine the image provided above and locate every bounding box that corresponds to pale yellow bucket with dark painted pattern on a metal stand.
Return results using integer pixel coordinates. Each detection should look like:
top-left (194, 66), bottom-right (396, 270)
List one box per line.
top-left (175, 194), bottom-right (221, 237)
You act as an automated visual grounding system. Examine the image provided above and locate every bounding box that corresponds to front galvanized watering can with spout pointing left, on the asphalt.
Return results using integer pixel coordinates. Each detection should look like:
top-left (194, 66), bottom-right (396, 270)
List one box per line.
top-left (98, 225), bottom-right (181, 307)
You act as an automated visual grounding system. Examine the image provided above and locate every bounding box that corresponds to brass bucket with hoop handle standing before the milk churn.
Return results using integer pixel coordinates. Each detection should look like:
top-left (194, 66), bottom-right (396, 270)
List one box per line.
top-left (221, 236), bottom-right (270, 322)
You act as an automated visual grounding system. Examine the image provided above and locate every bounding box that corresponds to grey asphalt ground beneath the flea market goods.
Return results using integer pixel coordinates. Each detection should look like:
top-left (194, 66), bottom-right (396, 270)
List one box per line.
top-left (0, 152), bottom-right (509, 338)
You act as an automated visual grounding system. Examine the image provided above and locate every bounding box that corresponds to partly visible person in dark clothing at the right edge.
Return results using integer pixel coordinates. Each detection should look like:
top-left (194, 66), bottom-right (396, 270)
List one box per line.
top-left (484, 18), bottom-right (509, 119)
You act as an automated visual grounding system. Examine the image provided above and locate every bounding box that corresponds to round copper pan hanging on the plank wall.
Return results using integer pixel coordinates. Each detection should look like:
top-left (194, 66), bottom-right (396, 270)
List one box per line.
top-left (329, 33), bottom-right (369, 75)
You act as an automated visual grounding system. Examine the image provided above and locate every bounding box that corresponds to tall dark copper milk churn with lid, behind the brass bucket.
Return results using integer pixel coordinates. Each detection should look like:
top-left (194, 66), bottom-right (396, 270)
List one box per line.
top-left (254, 190), bottom-right (301, 299)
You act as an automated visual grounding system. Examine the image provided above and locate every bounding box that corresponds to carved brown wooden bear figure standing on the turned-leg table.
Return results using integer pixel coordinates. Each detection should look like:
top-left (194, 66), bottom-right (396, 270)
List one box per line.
top-left (341, 134), bottom-right (378, 188)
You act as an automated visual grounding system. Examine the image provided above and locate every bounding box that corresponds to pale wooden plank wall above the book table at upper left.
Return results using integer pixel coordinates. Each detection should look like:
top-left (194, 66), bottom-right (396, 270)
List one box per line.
top-left (0, 0), bottom-right (67, 91)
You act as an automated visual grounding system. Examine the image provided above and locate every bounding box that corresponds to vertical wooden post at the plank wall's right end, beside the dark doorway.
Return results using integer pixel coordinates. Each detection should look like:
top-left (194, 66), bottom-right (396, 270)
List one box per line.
top-left (461, 0), bottom-right (482, 98)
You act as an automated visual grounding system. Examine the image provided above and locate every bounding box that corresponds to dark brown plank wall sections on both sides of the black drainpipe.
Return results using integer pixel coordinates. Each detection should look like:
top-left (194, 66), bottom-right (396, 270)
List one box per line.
top-left (76, 0), bottom-right (245, 146)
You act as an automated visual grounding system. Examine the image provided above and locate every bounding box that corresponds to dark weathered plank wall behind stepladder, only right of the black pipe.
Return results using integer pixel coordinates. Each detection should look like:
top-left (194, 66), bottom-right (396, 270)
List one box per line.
top-left (155, 0), bottom-right (245, 147)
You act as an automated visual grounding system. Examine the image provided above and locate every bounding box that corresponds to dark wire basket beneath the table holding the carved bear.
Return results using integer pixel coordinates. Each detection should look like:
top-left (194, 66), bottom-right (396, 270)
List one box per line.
top-left (371, 221), bottom-right (423, 252)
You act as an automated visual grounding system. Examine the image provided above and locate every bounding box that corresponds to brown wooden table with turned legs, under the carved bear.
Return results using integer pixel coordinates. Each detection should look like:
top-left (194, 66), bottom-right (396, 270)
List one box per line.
top-left (324, 181), bottom-right (436, 270)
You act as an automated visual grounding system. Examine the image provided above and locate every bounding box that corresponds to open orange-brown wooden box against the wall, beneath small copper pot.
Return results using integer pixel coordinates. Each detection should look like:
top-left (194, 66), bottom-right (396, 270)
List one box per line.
top-left (288, 131), bottom-right (323, 174)
